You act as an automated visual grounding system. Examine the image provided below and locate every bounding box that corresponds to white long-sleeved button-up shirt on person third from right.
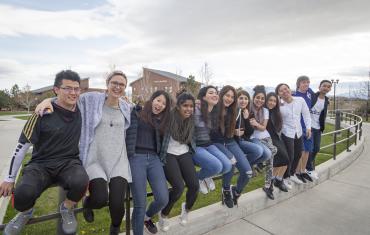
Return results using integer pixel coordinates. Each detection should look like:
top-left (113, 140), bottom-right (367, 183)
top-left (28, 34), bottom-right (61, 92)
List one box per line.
top-left (280, 96), bottom-right (311, 139)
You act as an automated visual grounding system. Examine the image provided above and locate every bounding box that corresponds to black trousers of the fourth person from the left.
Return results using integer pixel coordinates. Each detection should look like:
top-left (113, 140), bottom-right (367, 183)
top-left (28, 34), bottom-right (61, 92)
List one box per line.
top-left (162, 153), bottom-right (199, 216)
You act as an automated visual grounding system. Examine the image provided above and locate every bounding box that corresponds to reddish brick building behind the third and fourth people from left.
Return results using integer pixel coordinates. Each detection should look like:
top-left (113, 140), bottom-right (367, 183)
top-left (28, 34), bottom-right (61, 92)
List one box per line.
top-left (130, 68), bottom-right (200, 102)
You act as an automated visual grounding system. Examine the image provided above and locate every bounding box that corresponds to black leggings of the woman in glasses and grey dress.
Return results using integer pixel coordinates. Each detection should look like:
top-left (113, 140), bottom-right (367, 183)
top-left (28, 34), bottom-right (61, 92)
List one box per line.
top-left (84, 176), bottom-right (127, 227)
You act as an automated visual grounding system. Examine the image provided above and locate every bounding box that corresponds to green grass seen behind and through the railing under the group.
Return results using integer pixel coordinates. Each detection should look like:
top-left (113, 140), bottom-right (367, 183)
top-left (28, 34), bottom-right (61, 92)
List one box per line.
top-left (4, 124), bottom-right (360, 235)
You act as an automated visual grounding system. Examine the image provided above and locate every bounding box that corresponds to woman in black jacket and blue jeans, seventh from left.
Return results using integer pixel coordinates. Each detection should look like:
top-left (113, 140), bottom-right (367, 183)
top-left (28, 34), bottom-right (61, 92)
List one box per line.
top-left (235, 90), bottom-right (268, 174)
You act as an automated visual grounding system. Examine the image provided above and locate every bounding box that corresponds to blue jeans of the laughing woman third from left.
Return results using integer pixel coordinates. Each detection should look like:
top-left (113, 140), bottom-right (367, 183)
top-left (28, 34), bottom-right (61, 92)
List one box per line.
top-left (129, 154), bottom-right (168, 235)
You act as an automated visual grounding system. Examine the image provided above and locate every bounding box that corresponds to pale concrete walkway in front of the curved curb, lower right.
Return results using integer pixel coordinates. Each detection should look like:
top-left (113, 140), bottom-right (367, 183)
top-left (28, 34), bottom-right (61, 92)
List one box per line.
top-left (207, 125), bottom-right (370, 235)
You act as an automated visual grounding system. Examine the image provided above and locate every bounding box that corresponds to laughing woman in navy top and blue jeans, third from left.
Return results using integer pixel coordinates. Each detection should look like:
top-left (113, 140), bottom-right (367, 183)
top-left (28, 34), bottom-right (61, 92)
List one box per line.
top-left (126, 90), bottom-right (171, 235)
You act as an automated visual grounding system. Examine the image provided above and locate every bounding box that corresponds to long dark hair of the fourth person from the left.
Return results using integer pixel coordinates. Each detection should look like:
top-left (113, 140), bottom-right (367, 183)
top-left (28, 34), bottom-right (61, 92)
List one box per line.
top-left (169, 92), bottom-right (195, 144)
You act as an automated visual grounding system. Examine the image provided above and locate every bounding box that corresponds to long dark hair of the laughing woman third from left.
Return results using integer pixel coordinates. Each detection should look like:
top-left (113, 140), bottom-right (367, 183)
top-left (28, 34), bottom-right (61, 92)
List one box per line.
top-left (140, 90), bottom-right (171, 134)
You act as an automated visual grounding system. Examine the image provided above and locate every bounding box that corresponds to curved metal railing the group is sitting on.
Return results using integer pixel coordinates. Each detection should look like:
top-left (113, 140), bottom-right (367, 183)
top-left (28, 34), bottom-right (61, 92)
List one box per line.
top-left (0, 110), bottom-right (362, 235)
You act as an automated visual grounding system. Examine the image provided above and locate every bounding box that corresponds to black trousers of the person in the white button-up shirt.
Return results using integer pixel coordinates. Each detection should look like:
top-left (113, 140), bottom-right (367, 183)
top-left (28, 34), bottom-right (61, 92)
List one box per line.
top-left (281, 134), bottom-right (303, 178)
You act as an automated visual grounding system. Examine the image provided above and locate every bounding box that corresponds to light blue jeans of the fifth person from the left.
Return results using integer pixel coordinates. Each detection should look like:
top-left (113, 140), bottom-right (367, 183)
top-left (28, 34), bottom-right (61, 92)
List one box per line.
top-left (193, 144), bottom-right (231, 180)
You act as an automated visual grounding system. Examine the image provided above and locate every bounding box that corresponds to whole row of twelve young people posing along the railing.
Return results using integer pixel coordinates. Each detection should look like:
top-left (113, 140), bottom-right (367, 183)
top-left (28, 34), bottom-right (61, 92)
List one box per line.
top-left (0, 70), bottom-right (331, 235)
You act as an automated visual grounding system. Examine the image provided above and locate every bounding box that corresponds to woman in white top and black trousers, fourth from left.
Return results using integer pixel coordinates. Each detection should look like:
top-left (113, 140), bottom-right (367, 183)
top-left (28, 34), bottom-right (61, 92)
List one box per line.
top-left (159, 91), bottom-right (199, 231)
